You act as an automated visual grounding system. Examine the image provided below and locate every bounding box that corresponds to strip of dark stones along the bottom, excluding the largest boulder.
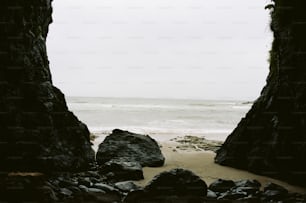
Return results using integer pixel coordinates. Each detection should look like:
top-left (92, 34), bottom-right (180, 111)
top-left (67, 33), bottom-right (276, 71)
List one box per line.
top-left (0, 169), bottom-right (306, 203)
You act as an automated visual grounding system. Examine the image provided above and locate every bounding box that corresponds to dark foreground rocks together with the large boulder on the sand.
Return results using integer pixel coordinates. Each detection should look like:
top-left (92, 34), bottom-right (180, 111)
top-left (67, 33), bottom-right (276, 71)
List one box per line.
top-left (0, 129), bottom-right (306, 203)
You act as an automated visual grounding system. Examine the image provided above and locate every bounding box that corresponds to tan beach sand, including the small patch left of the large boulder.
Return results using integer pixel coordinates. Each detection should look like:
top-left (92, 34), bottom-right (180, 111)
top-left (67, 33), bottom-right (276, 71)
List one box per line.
top-left (92, 133), bottom-right (306, 194)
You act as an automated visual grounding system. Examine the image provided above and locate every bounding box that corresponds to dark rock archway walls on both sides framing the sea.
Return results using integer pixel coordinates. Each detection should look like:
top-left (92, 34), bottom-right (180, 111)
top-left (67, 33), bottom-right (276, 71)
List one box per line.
top-left (0, 0), bottom-right (306, 187)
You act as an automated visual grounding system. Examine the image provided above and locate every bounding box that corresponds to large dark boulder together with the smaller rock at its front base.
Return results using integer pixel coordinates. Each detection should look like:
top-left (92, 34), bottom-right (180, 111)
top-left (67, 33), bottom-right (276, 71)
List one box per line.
top-left (96, 129), bottom-right (165, 181)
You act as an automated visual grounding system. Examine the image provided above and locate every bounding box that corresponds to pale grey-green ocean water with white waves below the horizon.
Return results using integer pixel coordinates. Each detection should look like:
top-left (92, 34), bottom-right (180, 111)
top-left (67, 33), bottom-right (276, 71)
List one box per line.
top-left (67, 97), bottom-right (252, 141)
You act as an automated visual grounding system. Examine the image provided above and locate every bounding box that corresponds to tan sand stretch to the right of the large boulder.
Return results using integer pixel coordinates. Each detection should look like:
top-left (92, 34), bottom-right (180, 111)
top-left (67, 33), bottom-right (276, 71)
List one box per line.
top-left (135, 141), bottom-right (306, 193)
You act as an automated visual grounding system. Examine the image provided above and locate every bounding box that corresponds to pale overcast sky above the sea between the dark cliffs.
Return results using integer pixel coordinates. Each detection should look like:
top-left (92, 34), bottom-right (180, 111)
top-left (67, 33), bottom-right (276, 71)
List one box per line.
top-left (47, 0), bottom-right (272, 100)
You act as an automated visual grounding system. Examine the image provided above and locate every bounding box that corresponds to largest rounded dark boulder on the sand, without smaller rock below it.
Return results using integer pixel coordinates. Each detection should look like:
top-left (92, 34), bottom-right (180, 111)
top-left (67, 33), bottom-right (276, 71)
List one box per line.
top-left (96, 129), bottom-right (165, 167)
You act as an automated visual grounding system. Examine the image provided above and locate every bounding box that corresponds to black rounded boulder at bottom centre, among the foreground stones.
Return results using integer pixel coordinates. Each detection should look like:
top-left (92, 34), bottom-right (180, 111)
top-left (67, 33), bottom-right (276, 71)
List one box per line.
top-left (124, 168), bottom-right (207, 202)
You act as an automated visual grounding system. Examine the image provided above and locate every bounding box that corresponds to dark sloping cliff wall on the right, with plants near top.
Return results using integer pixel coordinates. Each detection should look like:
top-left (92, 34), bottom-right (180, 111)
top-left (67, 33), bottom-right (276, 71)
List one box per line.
top-left (215, 0), bottom-right (306, 185)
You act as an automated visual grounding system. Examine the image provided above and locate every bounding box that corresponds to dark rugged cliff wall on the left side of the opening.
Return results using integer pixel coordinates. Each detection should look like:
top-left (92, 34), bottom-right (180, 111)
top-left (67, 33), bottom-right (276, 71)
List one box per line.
top-left (0, 0), bottom-right (94, 171)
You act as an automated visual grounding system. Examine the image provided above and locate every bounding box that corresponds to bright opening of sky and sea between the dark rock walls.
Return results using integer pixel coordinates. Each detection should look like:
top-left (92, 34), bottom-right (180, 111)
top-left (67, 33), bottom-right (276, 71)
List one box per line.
top-left (47, 0), bottom-right (272, 144)
